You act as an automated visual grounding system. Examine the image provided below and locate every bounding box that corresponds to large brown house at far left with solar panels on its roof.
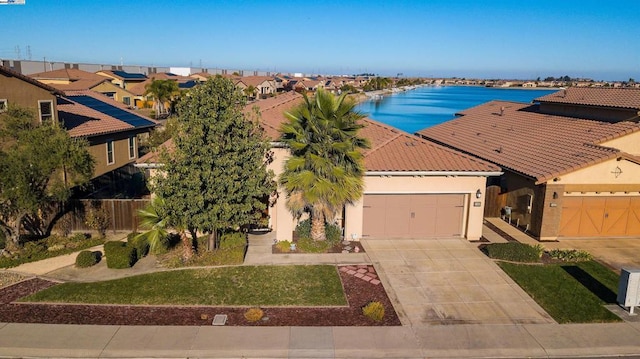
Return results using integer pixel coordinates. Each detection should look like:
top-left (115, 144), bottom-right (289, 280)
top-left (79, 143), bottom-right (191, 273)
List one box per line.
top-left (0, 66), bottom-right (156, 197)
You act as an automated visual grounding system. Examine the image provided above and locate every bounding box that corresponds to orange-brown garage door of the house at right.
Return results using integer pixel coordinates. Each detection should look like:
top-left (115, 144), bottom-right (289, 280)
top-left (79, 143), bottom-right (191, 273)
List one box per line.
top-left (559, 197), bottom-right (640, 237)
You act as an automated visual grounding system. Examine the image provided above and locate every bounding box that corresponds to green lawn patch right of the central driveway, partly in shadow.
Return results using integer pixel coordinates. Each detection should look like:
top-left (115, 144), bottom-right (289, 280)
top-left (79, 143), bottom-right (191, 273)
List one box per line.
top-left (498, 261), bottom-right (621, 323)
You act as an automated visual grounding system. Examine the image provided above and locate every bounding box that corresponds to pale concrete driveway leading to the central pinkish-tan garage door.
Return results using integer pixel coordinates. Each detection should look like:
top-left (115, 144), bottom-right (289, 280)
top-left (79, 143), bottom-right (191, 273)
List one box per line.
top-left (362, 239), bottom-right (554, 327)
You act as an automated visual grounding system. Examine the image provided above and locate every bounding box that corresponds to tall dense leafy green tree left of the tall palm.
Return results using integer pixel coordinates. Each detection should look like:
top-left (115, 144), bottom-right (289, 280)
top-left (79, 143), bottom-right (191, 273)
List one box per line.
top-left (156, 77), bottom-right (275, 256)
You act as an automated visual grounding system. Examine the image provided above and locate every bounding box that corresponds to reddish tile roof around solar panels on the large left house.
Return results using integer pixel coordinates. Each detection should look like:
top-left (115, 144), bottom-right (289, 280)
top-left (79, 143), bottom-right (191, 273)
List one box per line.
top-left (57, 91), bottom-right (156, 137)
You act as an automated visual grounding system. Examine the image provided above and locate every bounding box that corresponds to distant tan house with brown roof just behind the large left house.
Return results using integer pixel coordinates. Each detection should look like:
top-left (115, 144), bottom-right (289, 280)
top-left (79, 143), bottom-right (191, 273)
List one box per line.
top-left (30, 69), bottom-right (135, 106)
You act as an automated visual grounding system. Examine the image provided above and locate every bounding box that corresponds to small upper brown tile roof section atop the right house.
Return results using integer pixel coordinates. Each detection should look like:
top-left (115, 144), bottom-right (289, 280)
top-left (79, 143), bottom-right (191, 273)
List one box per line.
top-left (534, 87), bottom-right (640, 110)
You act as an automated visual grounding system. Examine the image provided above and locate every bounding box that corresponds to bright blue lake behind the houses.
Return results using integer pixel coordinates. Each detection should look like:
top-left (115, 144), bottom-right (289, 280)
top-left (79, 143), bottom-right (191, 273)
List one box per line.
top-left (356, 86), bottom-right (558, 133)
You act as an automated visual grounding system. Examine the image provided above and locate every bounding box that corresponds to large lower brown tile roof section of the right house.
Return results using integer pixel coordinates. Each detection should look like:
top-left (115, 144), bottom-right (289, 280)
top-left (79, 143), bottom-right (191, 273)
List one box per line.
top-left (418, 101), bottom-right (640, 183)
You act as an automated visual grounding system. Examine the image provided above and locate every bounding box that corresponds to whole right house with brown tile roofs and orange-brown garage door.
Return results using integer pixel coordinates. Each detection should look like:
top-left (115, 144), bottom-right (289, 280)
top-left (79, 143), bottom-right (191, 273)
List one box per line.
top-left (418, 88), bottom-right (640, 240)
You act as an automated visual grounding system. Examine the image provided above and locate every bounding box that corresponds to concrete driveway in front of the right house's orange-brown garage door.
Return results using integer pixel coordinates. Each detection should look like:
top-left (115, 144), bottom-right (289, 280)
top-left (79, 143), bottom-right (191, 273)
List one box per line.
top-left (542, 238), bottom-right (640, 273)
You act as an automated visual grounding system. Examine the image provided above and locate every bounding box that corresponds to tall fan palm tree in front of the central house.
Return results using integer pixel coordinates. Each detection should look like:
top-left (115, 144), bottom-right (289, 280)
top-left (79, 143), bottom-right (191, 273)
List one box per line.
top-left (279, 89), bottom-right (369, 240)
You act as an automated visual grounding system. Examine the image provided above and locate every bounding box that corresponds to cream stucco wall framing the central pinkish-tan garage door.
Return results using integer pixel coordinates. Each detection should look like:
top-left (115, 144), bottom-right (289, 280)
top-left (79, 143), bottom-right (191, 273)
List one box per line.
top-left (345, 176), bottom-right (486, 240)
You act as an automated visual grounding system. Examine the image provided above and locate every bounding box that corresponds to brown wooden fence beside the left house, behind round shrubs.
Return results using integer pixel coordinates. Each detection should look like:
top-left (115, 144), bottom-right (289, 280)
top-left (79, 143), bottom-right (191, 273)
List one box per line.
top-left (70, 199), bottom-right (150, 232)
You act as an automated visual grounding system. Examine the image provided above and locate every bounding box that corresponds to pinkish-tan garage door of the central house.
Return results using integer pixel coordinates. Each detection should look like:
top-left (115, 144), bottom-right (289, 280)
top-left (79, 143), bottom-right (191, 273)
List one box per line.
top-left (363, 194), bottom-right (464, 238)
